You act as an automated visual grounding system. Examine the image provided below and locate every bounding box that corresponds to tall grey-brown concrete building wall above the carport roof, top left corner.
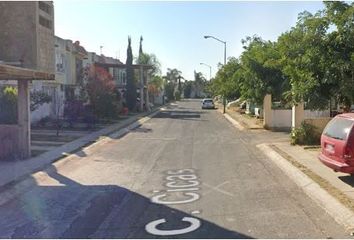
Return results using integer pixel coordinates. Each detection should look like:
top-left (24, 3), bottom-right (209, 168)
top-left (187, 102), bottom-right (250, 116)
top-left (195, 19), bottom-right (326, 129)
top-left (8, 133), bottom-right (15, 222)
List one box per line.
top-left (0, 1), bottom-right (54, 72)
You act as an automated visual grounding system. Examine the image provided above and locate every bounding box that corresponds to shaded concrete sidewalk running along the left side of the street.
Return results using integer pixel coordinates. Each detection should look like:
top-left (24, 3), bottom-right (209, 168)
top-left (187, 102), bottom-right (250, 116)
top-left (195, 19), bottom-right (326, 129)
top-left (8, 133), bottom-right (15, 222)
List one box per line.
top-left (0, 107), bottom-right (163, 188)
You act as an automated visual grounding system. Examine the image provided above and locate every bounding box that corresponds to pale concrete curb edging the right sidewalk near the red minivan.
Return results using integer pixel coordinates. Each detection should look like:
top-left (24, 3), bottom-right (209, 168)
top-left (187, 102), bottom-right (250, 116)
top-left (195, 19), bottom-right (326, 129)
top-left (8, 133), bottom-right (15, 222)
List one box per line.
top-left (257, 143), bottom-right (354, 230)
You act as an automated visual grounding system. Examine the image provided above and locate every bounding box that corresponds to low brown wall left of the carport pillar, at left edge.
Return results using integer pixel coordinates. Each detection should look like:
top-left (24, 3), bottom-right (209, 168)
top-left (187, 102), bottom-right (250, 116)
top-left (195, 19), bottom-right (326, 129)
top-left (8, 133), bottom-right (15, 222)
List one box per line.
top-left (0, 125), bottom-right (19, 160)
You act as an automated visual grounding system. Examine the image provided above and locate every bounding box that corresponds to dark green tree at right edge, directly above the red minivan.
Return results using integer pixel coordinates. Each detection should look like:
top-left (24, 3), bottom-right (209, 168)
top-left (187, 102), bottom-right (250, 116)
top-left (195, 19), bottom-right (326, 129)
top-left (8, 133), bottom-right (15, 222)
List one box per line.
top-left (323, 2), bottom-right (354, 107)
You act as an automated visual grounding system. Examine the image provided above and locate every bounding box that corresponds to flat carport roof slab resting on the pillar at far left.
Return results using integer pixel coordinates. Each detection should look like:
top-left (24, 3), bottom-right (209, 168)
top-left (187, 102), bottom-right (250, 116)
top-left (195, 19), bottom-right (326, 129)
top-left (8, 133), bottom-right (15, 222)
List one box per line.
top-left (0, 64), bottom-right (55, 81)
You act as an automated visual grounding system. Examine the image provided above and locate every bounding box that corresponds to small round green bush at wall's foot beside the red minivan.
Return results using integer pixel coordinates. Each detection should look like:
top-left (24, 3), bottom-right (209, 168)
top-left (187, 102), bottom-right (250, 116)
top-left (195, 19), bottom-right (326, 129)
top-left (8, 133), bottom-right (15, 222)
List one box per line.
top-left (290, 122), bottom-right (321, 145)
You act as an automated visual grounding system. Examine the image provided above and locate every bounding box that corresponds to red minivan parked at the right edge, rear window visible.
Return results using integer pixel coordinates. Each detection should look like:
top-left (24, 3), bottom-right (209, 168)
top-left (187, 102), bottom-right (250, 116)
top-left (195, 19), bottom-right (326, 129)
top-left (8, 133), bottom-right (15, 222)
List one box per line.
top-left (318, 113), bottom-right (354, 174)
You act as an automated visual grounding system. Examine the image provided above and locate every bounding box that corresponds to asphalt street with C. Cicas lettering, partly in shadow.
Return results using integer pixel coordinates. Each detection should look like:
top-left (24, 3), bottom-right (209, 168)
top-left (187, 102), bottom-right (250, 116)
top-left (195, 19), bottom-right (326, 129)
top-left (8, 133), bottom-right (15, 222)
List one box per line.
top-left (0, 100), bottom-right (349, 238)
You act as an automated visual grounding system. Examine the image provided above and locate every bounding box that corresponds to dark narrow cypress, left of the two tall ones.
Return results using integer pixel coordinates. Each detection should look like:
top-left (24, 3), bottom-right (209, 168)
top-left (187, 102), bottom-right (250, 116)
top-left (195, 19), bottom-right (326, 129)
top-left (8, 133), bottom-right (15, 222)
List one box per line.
top-left (126, 36), bottom-right (137, 111)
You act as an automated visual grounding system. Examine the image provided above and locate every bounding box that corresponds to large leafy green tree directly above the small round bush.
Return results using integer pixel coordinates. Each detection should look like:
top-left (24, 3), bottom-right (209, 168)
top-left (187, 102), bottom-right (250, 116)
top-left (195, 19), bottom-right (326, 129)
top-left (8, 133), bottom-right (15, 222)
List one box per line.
top-left (278, 12), bottom-right (330, 109)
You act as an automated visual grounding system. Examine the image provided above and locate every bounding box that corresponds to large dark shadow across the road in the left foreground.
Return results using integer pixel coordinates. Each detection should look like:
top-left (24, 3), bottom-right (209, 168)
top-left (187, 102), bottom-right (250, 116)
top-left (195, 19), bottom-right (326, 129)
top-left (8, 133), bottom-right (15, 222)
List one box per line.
top-left (0, 166), bottom-right (250, 239)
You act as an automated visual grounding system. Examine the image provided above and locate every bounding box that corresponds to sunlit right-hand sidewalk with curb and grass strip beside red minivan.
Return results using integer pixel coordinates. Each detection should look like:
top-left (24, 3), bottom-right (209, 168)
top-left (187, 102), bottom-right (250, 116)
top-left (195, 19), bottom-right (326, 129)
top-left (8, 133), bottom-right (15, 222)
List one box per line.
top-left (224, 108), bottom-right (354, 230)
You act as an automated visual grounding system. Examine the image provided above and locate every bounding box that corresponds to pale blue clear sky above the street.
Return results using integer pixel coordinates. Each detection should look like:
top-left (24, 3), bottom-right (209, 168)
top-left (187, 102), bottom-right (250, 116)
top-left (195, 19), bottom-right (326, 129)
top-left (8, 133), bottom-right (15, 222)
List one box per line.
top-left (54, 0), bottom-right (324, 80)
